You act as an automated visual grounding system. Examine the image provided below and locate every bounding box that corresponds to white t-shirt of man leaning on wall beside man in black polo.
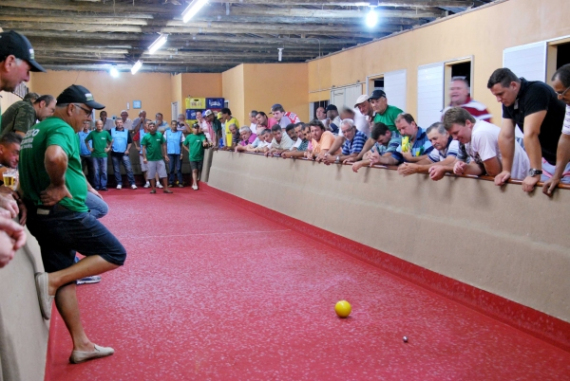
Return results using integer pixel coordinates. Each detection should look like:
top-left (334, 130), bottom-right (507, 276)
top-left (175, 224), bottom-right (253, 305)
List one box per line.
top-left (465, 120), bottom-right (530, 180)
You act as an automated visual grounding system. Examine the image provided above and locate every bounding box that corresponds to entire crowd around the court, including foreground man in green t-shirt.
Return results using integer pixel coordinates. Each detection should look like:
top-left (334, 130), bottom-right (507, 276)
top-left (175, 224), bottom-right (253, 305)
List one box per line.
top-left (0, 31), bottom-right (570, 363)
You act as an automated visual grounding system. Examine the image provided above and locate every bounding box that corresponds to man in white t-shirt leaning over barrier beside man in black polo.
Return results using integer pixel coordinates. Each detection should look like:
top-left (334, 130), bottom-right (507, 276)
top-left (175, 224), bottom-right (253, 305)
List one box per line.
top-left (443, 107), bottom-right (530, 180)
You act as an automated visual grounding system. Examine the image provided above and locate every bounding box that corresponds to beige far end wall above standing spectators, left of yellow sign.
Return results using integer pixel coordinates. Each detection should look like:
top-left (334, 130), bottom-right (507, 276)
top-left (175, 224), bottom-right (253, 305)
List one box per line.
top-left (31, 71), bottom-right (173, 120)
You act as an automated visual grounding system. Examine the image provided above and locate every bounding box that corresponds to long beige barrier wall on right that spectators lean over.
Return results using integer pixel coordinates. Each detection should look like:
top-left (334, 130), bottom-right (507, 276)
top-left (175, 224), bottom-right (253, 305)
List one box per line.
top-left (208, 152), bottom-right (570, 322)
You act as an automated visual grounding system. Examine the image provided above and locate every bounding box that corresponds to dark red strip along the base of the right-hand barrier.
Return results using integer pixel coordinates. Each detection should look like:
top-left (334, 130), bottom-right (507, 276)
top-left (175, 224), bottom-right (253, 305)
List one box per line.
top-left (200, 182), bottom-right (570, 352)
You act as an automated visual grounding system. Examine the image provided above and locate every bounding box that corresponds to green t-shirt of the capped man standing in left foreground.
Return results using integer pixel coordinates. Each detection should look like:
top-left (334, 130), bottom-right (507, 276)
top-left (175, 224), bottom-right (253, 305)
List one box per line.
top-left (18, 117), bottom-right (89, 212)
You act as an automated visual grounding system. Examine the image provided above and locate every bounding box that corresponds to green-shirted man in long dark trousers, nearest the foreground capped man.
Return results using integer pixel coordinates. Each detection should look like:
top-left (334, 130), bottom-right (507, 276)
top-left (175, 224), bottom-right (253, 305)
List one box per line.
top-left (85, 120), bottom-right (113, 191)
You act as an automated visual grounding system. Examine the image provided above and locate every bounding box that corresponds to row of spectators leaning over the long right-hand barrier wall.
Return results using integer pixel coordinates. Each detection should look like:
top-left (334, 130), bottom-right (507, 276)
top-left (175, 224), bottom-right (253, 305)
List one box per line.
top-left (219, 69), bottom-right (570, 196)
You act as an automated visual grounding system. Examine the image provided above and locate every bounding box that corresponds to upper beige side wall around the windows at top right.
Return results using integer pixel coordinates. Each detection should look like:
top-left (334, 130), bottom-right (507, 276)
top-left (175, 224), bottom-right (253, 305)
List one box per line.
top-left (308, 0), bottom-right (570, 121)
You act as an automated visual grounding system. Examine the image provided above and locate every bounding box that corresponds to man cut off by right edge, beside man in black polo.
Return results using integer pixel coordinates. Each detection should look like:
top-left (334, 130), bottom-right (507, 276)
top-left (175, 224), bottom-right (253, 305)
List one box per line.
top-left (542, 64), bottom-right (570, 196)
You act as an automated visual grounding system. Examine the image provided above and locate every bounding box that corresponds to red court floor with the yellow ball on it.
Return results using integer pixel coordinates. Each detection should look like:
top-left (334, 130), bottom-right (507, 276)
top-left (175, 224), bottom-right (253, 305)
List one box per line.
top-left (46, 187), bottom-right (570, 381)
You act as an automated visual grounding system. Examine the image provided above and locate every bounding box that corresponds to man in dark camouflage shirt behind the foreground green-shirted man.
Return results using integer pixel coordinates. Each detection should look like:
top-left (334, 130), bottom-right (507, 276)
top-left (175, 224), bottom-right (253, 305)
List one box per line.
top-left (0, 95), bottom-right (55, 137)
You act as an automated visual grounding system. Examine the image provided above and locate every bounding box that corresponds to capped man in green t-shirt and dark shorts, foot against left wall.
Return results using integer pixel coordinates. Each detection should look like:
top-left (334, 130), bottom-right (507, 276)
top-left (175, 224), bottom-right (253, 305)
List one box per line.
top-left (19, 85), bottom-right (127, 363)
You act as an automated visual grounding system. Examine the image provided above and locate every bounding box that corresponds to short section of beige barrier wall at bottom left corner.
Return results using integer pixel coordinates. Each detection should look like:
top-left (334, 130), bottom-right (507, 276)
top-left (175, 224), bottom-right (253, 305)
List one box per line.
top-left (0, 232), bottom-right (49, 381)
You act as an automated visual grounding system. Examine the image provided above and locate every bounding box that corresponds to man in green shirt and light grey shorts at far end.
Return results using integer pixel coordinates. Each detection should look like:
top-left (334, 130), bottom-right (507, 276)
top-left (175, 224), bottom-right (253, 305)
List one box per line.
top-left (141, 122), bottom-right (172, 194)
